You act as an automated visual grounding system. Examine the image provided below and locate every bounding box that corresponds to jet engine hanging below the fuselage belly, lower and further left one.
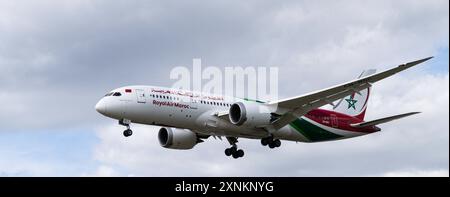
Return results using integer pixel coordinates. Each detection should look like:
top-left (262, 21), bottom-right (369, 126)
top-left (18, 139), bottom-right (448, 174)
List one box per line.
top-left (158, 127), bottom-right (198, 150)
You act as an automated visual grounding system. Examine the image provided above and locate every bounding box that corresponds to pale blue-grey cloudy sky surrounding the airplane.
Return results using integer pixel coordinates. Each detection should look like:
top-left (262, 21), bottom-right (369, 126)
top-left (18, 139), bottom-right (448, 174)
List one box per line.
top-left (0, 0), bottom-right (449, 176)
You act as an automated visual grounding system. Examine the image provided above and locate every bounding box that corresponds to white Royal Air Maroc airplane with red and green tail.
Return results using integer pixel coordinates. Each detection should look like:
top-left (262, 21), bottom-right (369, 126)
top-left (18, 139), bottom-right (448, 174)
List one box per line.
top-left (95, 57), bottom-right (433, 159)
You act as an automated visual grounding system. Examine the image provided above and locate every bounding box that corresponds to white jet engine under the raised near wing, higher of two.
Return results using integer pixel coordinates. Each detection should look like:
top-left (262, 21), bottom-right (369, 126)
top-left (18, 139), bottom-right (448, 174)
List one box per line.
top-left (229, 102), bottom-right (273, 127)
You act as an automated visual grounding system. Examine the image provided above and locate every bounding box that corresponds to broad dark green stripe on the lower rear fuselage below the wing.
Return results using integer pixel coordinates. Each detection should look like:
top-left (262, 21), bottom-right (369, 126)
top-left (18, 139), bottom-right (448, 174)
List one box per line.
top-left (289, 118), bottom-right (342, 142)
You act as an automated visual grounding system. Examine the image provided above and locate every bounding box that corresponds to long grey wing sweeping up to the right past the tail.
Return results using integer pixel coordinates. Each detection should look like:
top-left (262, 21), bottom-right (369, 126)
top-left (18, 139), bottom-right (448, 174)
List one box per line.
top-left (267, 57), bottom-right (433, 130)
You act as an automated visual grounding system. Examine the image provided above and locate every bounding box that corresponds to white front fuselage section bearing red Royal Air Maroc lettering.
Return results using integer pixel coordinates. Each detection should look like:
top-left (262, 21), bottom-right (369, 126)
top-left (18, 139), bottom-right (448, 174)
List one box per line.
top-left (96, 86), bottom-right (308, 141)
